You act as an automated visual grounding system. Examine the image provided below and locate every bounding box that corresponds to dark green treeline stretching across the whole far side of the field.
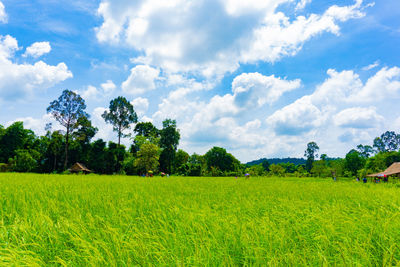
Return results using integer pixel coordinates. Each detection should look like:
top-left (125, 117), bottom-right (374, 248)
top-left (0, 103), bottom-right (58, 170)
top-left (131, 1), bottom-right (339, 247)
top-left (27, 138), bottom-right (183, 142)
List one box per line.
top-left (0, 90), bottom-right (400, 178)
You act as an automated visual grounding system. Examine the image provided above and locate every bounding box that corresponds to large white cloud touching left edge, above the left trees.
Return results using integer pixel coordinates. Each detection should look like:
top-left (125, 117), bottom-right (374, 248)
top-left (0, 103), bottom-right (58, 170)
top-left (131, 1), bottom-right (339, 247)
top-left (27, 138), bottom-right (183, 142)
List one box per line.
top-left (0, 35), bottom-right (72, 100)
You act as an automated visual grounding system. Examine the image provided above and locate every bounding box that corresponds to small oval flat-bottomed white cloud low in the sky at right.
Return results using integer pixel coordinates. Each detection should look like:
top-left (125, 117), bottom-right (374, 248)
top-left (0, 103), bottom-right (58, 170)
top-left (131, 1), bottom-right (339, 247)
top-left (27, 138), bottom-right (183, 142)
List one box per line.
top-left (333, 107), bottom-right (384, 129)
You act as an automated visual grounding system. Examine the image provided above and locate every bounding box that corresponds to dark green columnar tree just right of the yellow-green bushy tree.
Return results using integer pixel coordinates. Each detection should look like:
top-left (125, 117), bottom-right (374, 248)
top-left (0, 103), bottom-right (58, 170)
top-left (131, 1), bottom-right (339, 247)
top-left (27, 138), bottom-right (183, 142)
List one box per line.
top-left (160, 119), bottom-right (181, 173)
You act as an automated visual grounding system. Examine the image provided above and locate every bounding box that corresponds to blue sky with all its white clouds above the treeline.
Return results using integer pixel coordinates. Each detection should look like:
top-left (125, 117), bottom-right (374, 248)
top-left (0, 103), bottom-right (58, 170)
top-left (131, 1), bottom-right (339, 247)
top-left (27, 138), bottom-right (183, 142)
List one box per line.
top-left (0, 0), bottom-right (400, 162)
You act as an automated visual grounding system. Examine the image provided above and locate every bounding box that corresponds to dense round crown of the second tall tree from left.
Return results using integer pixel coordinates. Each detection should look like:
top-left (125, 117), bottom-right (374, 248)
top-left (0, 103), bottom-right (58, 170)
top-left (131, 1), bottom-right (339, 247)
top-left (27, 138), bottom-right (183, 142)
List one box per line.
top-left (101, 96), bottom-right (137, 145)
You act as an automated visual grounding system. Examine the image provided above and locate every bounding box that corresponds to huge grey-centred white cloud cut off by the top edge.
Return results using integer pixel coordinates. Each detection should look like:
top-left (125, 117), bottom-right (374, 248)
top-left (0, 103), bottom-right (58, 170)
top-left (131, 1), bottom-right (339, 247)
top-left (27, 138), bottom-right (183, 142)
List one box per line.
top-left (96, 0), bottom-right (364, 78)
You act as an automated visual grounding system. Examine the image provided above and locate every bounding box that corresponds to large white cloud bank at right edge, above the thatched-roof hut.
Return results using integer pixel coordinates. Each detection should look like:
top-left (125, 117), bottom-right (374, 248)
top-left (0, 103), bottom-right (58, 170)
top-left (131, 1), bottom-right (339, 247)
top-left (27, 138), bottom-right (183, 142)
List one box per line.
top-left (266, 67), bottom-right (400, 154)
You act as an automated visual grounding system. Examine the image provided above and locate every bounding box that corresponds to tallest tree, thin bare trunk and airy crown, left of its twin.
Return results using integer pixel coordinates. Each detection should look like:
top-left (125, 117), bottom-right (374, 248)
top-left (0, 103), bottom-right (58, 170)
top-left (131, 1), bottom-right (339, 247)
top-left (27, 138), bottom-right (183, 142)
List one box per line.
top-left (47, 90), bottom-right (89, 170)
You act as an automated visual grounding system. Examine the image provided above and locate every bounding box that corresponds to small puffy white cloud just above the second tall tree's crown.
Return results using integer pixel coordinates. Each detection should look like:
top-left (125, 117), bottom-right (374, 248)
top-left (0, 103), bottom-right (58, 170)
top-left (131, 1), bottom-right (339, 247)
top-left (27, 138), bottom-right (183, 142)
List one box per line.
top-left (121, 65), bottom-right (160, 95)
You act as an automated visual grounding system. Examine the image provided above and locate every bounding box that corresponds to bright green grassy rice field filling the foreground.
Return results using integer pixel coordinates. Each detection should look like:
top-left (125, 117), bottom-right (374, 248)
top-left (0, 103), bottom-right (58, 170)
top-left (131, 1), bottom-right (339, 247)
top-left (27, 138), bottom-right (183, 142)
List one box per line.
top-left (0, 174), bottom-right (400, 266)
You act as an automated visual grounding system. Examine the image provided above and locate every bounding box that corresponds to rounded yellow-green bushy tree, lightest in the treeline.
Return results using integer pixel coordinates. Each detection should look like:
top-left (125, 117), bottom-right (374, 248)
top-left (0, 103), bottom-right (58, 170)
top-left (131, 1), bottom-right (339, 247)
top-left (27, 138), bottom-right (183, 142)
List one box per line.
top-left (135, 144), bottom-right (159, 173)
